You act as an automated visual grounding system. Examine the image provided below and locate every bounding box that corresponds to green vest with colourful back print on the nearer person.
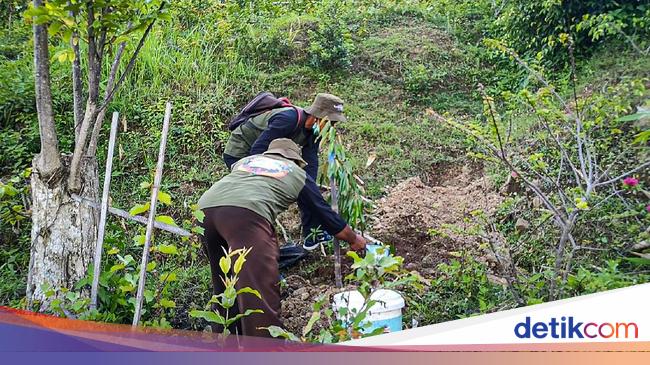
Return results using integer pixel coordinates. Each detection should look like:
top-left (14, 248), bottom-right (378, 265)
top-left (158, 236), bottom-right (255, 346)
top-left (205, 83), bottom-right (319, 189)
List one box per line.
top-left (198, 155), bottom-right (307, 225)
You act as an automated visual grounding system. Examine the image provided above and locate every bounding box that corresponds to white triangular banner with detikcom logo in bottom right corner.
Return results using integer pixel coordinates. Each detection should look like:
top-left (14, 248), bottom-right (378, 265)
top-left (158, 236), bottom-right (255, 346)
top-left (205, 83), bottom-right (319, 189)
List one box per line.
top-left (345, 284), bottom-right (650, 346)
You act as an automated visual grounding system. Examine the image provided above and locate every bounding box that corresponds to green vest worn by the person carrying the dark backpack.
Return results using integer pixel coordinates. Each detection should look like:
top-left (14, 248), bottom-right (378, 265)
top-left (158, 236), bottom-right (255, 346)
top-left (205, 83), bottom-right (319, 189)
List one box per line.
top-left (223, 107), bottom-right (308, 159)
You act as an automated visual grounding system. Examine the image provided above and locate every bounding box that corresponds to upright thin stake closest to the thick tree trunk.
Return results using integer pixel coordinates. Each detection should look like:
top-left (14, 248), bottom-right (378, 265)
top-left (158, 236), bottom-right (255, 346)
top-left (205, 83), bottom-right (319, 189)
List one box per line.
top-left (90, 112), bottom-right (120, 309)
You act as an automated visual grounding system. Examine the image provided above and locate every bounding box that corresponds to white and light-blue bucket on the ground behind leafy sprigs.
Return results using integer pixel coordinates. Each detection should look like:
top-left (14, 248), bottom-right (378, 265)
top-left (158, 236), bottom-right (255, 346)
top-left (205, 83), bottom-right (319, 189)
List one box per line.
top-left (332, 289), bottom-right (404, 333)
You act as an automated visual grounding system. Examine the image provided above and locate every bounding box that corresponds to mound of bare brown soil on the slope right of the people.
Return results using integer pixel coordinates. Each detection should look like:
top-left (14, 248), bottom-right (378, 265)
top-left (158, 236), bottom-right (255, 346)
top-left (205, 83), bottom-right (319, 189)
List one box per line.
top-left (372, 165), bottom-right (502, 274)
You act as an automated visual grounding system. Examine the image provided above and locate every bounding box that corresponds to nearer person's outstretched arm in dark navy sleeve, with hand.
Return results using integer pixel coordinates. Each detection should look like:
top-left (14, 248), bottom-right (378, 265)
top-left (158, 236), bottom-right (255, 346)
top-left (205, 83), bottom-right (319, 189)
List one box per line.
top-left (298, 175), bottom-right (366, 251)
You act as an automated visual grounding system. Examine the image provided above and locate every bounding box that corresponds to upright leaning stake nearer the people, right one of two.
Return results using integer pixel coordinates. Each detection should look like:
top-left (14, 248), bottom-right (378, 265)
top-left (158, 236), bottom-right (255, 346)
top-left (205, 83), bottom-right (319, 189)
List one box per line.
top-left (132, 102), bottom-right (172, 327)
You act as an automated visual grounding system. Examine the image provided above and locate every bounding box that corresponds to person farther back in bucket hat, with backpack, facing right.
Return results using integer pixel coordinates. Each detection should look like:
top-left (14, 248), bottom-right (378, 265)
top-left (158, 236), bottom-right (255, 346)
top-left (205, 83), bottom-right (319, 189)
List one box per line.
top-left (223, 93), bottom-right (347, 251)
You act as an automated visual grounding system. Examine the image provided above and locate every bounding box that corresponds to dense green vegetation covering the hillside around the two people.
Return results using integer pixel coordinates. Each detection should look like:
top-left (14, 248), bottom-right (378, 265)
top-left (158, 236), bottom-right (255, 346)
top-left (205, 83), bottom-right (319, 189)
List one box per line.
top-left (0, 0), bottom-right (650, 334)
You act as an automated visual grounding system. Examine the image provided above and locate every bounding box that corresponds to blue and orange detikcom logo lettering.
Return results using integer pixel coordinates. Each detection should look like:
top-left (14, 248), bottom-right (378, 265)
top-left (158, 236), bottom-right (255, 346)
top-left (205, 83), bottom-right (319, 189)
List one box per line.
top-left (514, 316), bottom-right (639, 338)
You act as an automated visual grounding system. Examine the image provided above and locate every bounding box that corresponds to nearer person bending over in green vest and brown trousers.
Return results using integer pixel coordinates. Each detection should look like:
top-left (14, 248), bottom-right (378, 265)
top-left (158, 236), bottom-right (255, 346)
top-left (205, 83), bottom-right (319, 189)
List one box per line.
top-left (198, 138), bottom-right (366, 336)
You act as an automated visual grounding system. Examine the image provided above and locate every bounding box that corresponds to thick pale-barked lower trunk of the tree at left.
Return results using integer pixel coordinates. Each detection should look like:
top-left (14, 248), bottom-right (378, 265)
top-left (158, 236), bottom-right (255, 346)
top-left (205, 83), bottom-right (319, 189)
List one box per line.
top-left (27, 156), bottom-right (99, 308)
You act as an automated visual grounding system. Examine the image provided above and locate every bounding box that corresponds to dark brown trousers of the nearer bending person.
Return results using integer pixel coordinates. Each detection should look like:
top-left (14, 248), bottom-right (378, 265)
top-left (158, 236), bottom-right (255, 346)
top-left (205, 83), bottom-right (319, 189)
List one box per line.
top-left (197, 206), bottom-right (282, 337)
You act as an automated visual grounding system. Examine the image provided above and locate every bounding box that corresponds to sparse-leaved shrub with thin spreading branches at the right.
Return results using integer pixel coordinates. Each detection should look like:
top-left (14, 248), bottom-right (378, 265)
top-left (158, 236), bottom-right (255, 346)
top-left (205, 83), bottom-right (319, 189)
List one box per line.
top-left (431, 39), bottom-right (650, 298)
